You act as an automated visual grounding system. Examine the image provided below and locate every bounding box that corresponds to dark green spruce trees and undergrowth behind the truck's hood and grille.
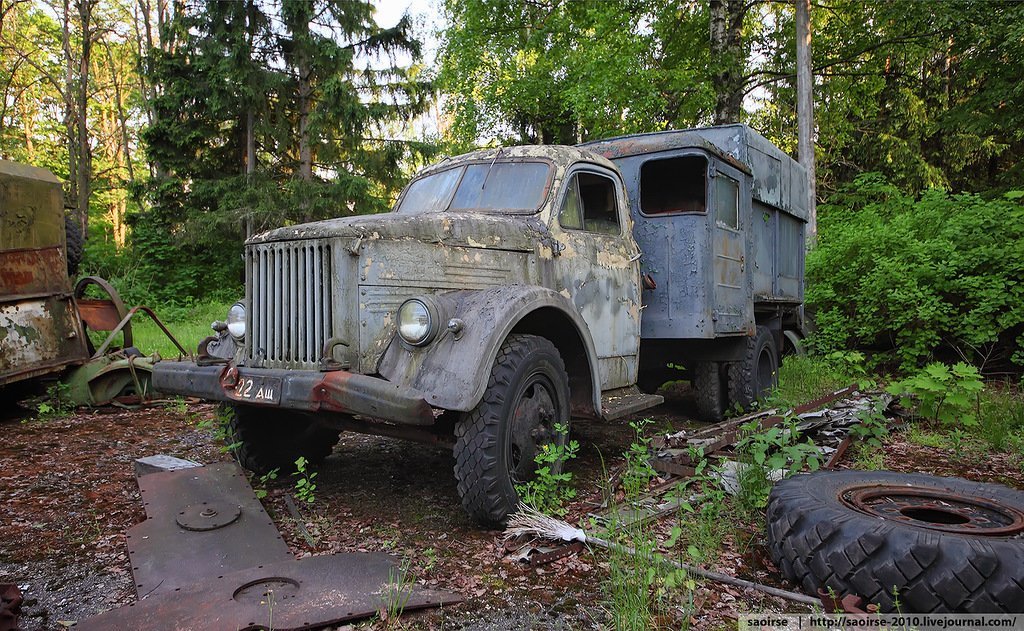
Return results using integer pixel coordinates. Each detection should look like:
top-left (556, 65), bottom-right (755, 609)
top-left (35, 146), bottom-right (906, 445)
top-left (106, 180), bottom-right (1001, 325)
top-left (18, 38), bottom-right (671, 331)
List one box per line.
top-left (130, 0), bottom-right (434, 301)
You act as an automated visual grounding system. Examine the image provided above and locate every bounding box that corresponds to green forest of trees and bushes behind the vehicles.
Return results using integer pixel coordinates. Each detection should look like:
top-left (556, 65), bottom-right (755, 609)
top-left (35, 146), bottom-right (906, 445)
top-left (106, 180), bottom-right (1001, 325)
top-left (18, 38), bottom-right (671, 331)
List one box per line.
top-left (0, 0), bottom-right (1024, 379)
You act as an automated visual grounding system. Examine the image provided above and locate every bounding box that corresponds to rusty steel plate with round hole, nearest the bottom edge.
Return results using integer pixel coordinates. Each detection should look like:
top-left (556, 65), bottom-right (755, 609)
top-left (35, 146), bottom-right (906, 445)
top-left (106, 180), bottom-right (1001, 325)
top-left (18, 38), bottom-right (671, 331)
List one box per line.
top-left (76, 553), bottom-right (462, 631)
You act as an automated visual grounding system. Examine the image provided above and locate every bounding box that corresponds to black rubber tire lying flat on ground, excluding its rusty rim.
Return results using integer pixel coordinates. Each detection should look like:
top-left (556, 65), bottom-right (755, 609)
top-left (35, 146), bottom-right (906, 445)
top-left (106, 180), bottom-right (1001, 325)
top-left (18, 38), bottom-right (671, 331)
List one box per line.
top-left (767, 471), bottom-right (1024, 614)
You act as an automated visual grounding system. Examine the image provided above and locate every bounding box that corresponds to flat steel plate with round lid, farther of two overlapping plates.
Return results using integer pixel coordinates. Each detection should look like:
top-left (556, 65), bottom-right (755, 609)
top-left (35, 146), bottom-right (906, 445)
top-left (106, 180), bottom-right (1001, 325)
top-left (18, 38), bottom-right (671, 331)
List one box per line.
top-left (128, 462), bottom-right (294, 598)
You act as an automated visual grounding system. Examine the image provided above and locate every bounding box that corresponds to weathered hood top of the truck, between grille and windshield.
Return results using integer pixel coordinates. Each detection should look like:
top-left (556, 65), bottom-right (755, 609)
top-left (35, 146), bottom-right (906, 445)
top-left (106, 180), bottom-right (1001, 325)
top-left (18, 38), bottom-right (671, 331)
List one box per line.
top-left (248, 212), bottom-right (552, 252)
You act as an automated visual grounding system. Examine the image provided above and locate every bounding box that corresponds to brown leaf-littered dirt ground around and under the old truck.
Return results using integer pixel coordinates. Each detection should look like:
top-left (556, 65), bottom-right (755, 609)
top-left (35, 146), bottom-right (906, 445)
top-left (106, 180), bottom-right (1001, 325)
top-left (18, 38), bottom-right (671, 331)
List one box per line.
top-left (0, 387), bottom-right (1024, 631)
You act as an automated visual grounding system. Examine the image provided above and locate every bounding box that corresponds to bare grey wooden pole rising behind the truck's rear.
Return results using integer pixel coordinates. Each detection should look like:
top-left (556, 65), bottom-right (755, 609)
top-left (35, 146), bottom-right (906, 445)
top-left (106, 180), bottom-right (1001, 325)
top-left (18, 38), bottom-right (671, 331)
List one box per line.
top-left (795, 0), bottom-right (818, 248)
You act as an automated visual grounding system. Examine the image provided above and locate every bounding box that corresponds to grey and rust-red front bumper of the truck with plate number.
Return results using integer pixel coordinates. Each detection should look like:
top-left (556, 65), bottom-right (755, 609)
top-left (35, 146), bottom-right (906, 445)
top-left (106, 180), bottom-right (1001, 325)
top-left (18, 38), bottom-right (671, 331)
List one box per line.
top-left (153, 360), bottom-right (434, 425)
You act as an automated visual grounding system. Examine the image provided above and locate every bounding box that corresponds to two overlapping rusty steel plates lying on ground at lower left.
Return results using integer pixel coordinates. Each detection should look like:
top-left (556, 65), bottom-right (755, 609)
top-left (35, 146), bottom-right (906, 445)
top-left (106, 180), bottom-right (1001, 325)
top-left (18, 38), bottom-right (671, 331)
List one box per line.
top-left (78, 459), bottom-right (462, 631)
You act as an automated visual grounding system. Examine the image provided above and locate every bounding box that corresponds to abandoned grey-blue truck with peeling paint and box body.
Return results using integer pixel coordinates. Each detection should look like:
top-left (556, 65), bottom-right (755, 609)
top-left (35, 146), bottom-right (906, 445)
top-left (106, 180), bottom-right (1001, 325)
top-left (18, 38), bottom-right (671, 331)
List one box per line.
top-left (154, 125), bottom-right (807, 524)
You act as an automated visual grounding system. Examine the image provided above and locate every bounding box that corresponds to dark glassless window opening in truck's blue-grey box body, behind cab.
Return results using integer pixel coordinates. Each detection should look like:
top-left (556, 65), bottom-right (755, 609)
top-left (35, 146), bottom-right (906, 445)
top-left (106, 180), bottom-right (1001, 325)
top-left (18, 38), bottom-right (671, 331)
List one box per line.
top-left (640, 156), bottom-right (708, 215)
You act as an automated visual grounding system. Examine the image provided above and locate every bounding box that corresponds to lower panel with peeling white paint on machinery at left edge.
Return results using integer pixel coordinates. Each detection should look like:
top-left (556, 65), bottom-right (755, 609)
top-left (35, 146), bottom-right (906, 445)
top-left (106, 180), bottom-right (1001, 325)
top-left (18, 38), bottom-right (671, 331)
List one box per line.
top-left (0, 295), bottom-right (89, 384)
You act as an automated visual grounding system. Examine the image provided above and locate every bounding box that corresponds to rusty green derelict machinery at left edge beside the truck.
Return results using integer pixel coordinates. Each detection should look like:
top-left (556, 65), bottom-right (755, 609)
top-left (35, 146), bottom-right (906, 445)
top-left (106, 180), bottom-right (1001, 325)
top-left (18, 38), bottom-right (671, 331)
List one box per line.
top-left (0, 160), bottom-right (185, 405)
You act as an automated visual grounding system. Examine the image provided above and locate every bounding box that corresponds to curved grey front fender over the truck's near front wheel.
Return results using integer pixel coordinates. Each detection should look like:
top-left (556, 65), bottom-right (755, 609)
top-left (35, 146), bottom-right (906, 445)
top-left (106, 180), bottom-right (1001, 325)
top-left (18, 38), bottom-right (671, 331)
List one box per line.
top-left (379, 285), bottom-right (601, 412)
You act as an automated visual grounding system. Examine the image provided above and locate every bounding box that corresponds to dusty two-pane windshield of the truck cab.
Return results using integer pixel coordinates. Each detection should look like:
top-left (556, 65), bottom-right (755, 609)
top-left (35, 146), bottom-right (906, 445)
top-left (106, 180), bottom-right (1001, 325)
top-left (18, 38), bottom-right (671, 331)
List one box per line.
top-left (395, 162), bottom-right (551, 215)
